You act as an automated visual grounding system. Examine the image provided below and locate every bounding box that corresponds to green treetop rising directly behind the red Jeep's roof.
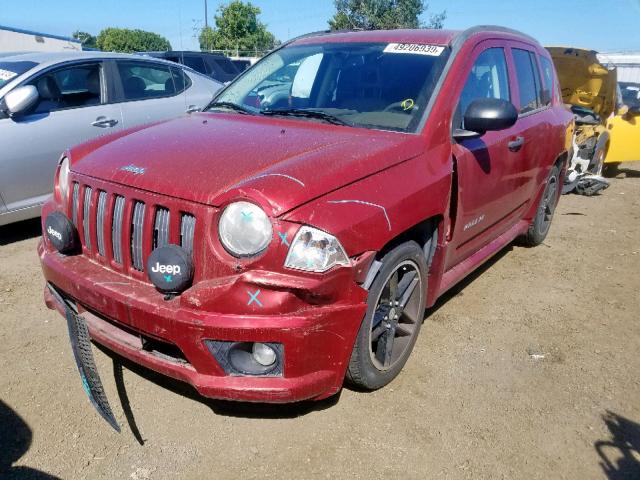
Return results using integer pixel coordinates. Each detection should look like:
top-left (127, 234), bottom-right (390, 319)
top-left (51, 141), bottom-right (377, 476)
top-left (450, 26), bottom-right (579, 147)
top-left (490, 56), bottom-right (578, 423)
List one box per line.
top-left (329, 0), bottom-right (447, 30)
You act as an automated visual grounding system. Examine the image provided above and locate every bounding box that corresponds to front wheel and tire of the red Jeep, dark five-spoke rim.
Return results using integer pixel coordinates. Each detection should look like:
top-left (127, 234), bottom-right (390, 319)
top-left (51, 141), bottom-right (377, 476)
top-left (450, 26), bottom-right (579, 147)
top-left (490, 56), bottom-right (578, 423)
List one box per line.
top-left (347, 242), bottom-right (427, 390)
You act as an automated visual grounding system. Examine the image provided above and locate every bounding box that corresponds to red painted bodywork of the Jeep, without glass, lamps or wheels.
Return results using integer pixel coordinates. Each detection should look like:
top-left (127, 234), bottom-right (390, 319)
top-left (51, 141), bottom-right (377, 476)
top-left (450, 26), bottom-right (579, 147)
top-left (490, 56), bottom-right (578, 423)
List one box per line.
top-left (39, 30), bottom-right (571, 402)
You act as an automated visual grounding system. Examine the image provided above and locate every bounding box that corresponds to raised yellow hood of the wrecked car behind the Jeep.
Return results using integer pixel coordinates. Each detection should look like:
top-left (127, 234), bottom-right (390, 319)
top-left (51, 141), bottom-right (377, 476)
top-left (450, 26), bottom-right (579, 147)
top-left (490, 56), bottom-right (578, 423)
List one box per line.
top-left (547, 47), bottom-right (616, 121)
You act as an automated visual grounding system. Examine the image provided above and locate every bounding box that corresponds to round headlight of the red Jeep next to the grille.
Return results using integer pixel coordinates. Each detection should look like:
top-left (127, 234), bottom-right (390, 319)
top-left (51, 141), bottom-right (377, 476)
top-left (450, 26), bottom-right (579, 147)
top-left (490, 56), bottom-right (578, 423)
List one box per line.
top-left (218, 202), bottom-right (273, 257)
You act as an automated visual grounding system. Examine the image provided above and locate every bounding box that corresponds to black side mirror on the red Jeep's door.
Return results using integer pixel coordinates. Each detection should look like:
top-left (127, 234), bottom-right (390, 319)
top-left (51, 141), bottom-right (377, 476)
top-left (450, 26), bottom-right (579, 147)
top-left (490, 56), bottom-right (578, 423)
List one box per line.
top-left (453, 98), bottom-right (518, 138)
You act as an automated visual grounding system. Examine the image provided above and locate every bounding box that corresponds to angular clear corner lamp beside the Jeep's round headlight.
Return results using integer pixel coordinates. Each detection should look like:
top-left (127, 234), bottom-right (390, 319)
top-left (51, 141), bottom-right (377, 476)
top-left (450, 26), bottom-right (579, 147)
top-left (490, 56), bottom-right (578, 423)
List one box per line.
top-left (284, 226), bottom-right (349, 272)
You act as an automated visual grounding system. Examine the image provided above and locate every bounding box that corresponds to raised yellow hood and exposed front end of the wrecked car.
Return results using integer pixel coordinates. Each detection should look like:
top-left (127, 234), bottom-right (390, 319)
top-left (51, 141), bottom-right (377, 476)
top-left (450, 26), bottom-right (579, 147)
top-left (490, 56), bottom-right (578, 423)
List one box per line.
top-left (547, 47), bottom-right (617, 195)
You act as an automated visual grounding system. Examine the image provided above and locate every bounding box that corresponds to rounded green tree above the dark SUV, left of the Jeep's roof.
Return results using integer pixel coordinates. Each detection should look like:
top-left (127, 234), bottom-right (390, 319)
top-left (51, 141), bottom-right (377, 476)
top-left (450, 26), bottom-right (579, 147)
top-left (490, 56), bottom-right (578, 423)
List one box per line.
top-left (198, 0), bottom-right (277, 56)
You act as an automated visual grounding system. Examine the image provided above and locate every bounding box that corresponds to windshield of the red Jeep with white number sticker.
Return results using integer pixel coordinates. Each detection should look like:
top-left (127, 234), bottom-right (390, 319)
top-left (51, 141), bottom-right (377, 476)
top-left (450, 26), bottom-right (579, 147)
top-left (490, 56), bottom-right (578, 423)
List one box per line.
top-left (216, 43), bottom-right (449, 132)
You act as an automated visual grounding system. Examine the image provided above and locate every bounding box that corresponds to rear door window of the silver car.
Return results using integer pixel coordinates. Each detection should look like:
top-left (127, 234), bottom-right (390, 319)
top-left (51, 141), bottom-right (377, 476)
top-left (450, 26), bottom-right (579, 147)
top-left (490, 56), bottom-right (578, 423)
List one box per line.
top-left (118, 61), bottom-right (176, 101)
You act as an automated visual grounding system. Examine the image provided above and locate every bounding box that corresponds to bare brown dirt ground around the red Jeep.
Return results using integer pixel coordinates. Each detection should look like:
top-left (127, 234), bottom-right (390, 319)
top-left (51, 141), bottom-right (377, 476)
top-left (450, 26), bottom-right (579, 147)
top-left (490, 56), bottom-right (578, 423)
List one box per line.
top-left (0, 169), bottom-right (640, 480)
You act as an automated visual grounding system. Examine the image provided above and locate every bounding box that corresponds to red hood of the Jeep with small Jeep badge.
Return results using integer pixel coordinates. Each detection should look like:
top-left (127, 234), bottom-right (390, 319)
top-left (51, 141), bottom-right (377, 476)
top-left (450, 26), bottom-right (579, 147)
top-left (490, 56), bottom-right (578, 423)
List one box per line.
top-left (71, 113), bottom-right (424, 216)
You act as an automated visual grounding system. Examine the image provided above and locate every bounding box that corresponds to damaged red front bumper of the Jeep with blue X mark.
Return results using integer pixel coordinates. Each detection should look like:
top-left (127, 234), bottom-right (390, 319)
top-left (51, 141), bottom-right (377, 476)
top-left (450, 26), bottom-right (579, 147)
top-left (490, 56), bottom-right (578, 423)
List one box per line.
top-left (38, 241), bottom-right (372, 403)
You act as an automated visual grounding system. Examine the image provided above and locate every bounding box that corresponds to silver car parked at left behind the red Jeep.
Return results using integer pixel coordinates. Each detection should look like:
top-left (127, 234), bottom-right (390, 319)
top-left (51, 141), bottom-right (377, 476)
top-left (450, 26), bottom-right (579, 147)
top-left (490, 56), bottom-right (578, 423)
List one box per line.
top-left (0, 52), bottom-right (222, 226)
